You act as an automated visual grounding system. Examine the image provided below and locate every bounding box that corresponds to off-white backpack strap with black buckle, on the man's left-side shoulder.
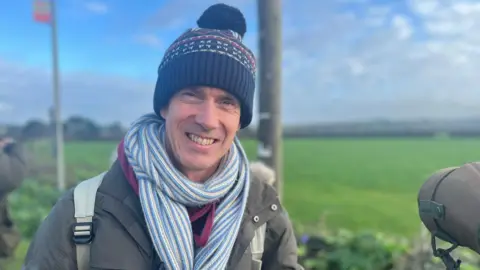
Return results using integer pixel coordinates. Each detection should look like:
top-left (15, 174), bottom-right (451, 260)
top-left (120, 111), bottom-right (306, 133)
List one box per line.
top-left (73, 172), bottom-right (106, 270)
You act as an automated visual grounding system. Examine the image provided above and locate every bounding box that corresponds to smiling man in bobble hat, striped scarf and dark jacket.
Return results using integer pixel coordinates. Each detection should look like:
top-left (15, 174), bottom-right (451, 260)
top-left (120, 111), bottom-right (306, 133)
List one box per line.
top-left (24, 4), bottom-right (300, 270)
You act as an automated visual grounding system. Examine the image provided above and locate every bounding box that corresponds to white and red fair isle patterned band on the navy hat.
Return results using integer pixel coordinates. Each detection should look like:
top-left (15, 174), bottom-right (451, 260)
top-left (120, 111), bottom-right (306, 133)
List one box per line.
top-left (159, 28), bottom-right (256, 78)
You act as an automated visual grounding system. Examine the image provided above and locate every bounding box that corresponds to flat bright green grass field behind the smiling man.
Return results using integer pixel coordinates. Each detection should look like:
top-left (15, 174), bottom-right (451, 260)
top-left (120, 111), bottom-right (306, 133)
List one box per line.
top-left (31, 139), bottom-right (480, 236)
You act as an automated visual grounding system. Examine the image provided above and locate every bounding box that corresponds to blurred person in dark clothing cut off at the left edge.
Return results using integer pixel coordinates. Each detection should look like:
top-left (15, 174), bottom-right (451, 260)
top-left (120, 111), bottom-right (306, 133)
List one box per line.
top-left (0, 136), bottom-right (26, 259)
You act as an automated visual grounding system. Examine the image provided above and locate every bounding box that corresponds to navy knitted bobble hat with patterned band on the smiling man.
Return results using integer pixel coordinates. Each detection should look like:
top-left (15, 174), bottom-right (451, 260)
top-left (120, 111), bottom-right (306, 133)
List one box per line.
top-left (153, 4), bottom-right (256, 128)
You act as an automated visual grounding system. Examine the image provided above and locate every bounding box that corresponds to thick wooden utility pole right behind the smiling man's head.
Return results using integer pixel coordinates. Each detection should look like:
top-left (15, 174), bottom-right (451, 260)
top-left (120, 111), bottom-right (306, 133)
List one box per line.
top-left (257, 0), bottom-right (283, 199)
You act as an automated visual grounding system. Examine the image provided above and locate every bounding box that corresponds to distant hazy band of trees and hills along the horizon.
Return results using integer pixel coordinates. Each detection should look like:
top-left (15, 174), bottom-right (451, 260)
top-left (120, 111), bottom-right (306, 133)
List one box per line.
top-left (0, 116), bottom-right (480, 141)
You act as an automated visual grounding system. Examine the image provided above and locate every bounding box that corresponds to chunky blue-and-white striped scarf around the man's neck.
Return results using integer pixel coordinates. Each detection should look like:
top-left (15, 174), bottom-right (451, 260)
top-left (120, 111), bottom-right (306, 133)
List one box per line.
top-left (125, 114), bottom-right (250, 270)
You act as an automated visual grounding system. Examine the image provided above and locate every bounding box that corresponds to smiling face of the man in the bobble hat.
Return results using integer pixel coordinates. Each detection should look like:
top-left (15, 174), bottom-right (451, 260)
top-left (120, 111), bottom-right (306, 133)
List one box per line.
top-left (161, 87), bottom-right (240, 181)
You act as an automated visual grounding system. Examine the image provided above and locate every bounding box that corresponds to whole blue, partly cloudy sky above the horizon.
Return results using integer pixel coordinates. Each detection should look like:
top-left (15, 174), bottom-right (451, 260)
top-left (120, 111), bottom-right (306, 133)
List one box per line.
top-left (0, 0), bottom-right (480, 123)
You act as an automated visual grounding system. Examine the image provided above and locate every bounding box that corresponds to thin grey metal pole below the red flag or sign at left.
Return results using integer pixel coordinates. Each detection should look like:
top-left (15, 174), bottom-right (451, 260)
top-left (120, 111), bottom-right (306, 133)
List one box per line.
top-left (50, 0), bottom-right (65, 191)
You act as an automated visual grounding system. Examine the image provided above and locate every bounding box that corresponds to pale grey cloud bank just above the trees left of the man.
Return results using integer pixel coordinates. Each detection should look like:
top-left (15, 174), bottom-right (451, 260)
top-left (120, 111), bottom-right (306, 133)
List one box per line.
top-left (0, 59), bottom-right (155, 123)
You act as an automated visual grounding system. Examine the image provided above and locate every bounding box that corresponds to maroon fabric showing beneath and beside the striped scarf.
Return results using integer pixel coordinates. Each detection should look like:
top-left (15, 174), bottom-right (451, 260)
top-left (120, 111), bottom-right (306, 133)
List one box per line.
top-left (117, 140), bottom-right (216, 247)
